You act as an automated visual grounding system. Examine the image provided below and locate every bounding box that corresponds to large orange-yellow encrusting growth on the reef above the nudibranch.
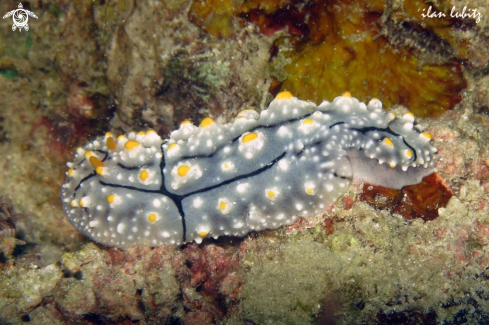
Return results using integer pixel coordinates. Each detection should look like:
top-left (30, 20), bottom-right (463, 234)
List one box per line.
top-left (191, 1), bottom-right (467, 117)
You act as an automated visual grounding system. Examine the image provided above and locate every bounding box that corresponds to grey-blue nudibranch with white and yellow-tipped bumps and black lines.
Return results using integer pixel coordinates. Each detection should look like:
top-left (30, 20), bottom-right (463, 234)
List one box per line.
top-left (61, 91), bottom-right (436, 248)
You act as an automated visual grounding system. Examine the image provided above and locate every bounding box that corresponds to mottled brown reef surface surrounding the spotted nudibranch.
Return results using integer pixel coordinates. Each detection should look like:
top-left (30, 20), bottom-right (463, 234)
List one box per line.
top-left (0, 0), bottom-right (489, 325)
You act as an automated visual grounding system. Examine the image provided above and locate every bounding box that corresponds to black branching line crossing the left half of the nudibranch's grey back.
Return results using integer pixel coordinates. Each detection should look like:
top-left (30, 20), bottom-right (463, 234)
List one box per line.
top-left (99, 152), bottom-right (286, 243)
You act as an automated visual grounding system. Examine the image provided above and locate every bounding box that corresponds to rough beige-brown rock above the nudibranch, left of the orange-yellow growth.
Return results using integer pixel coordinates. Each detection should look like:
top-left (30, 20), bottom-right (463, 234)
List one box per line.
top-left (100, 1), bottom-right (271, 135)
